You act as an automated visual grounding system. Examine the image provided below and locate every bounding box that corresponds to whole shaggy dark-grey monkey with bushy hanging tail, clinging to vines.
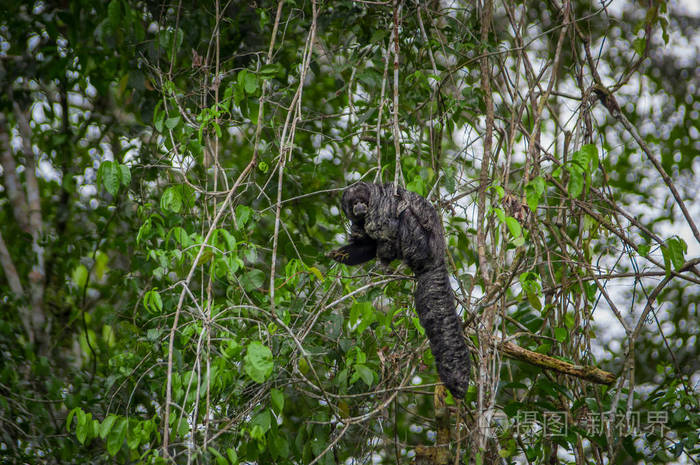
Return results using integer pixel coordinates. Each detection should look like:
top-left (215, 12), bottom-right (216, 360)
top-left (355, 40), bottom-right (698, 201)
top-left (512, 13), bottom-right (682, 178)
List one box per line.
top-left (329, 182), bottom-right (470, 398)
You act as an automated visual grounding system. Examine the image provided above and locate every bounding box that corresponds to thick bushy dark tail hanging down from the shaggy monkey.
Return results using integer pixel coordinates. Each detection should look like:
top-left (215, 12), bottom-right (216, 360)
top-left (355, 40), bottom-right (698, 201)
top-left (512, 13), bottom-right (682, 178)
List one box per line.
top-left (414, 266), bottom-right (470, 399)
